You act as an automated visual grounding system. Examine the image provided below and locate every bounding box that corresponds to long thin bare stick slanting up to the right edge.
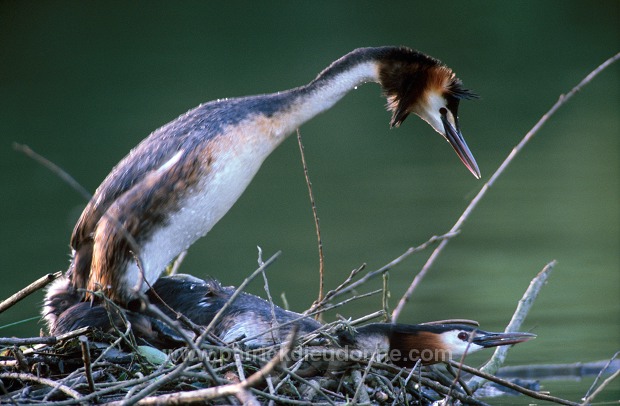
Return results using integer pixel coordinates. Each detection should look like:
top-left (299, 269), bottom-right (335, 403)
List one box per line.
top-left (392, 53), bottom-right (620, 322)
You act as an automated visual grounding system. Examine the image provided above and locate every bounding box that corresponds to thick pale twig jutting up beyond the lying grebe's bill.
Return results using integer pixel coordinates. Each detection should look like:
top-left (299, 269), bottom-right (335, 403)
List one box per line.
top-left (468, 261), bottom-right (556, 392)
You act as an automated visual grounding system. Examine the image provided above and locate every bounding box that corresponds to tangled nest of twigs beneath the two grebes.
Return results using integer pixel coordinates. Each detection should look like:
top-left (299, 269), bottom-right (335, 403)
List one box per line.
top-left (0, 260), bottom-right (573, 405)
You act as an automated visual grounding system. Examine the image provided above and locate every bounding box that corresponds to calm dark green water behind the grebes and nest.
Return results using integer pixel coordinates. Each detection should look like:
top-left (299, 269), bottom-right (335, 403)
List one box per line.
top-left (0, 1), bottom-right (620, 403)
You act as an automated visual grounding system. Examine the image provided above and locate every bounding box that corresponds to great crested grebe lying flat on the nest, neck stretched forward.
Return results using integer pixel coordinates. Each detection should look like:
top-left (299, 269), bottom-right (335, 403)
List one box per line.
top-left (44, 275), bottom-right (536, 369)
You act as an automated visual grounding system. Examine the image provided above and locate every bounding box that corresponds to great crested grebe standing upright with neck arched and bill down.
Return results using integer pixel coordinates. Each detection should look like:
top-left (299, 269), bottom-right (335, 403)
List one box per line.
top-left (63, 47), bottom-right (480, 305)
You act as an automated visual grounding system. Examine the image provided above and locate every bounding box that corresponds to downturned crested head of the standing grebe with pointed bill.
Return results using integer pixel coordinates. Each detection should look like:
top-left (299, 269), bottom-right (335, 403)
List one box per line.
top-left (379, 48), bottom-right (480, 179)
